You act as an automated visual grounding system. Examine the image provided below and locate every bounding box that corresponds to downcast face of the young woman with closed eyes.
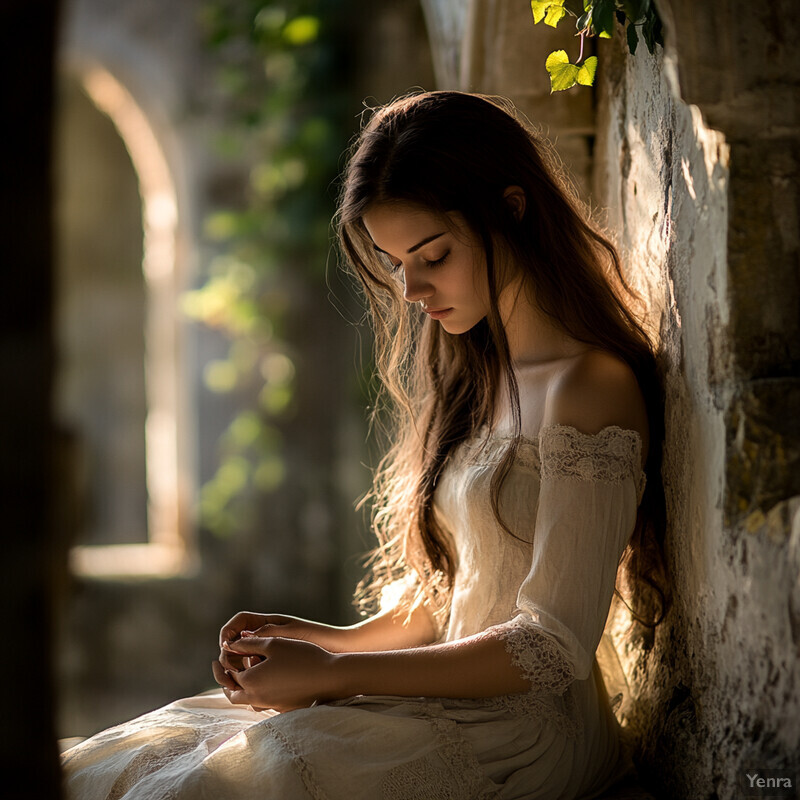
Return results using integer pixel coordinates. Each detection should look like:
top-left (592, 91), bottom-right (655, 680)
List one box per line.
top-left (363, 204), bottom-right (489, 333)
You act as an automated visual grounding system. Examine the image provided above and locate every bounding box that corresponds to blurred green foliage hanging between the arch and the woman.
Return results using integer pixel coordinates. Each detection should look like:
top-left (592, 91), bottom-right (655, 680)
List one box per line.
top-left (188, 0), bottom-right (348, 535)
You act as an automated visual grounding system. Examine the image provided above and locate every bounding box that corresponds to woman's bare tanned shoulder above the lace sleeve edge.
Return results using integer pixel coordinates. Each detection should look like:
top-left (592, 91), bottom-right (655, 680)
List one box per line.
top-left (542, 350), bottom-right (648, 452)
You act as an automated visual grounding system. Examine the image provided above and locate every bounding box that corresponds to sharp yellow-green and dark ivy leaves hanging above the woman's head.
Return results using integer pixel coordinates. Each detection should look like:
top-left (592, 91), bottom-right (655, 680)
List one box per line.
top-left (531, 0), bottom-right (664, 93)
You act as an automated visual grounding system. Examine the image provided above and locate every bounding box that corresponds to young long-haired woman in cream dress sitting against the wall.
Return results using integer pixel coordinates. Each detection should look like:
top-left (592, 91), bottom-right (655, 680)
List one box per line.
top-left (65, 92), bottom-right (665, 800)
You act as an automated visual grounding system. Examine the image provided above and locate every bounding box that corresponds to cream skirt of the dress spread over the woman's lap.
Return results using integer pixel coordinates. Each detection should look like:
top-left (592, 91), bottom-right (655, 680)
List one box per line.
top-left (63, 670), bottom-right (630, 800)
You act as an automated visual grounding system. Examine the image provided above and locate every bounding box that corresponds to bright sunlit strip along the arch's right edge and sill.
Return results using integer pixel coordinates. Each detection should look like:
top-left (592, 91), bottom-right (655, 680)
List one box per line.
top-left (71, 67), bottom-right (190, 576)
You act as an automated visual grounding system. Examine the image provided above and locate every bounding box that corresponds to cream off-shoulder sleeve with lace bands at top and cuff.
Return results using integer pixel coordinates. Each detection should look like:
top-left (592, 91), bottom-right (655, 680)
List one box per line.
top-left (493, 425), bottom-right (645, 694)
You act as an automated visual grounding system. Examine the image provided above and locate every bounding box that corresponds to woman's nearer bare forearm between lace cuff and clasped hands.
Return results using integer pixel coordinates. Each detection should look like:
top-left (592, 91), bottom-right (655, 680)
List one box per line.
top-left (332, 635), bottom-right (530, 698)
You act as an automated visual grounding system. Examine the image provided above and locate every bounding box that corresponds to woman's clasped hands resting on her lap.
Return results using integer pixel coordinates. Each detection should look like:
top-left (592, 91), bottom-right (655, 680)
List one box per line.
top-left (212, 612), bottom-right (336, 712)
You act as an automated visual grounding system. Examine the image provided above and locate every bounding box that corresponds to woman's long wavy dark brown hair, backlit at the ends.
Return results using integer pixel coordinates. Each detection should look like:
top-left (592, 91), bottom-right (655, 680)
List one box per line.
top-left (338, 92), bottom-right (667, 624)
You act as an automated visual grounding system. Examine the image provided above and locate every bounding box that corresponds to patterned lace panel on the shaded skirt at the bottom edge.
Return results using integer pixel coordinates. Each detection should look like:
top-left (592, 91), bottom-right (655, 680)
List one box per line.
top-left (380, 716), bottom-right (499, 800)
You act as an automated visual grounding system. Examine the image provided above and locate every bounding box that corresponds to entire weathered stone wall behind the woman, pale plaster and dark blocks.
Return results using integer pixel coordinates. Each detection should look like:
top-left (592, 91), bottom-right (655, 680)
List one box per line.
top-left (424, 0), bottom-right (800, 800)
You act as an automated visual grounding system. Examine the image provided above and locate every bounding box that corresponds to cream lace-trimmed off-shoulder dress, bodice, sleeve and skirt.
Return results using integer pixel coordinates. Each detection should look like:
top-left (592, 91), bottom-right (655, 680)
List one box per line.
top-left (64, 425), bottom-right (645, 800)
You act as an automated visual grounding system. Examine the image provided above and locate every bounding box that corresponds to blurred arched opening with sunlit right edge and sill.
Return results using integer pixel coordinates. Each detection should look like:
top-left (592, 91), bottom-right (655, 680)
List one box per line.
top-left (56, 67), bottom-right (191, 577)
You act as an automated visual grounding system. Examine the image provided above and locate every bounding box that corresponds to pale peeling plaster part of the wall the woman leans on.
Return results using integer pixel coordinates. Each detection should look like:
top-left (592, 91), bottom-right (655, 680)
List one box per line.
top-left (595, 21), bottom-right (800, 798)
